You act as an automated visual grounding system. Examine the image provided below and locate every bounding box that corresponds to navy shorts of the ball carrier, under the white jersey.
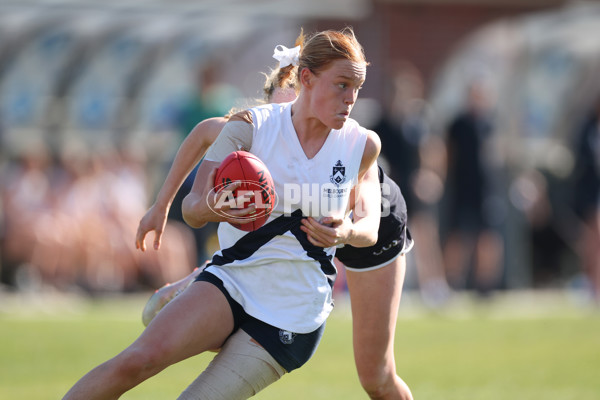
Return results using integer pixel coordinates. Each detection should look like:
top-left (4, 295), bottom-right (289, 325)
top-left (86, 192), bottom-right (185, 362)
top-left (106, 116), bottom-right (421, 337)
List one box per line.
top-left (196, 271), bottom-right (325, 372)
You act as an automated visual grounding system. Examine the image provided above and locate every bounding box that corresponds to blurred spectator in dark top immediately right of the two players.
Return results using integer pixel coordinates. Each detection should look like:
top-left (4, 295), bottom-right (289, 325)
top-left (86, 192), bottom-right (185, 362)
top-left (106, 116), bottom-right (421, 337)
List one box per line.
top-left (373, 62), bottom-right (450, 308)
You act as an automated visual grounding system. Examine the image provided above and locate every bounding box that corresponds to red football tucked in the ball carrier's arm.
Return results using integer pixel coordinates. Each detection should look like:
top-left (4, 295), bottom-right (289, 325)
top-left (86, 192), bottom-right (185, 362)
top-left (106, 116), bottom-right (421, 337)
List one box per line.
top-left (214, 151), bottom-right (276, 232)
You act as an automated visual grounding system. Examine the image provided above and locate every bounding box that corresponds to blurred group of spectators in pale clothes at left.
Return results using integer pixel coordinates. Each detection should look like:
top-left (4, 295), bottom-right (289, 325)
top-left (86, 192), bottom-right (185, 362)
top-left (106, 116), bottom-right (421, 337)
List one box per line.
top-left (0, 140), bottom-right (195, 292)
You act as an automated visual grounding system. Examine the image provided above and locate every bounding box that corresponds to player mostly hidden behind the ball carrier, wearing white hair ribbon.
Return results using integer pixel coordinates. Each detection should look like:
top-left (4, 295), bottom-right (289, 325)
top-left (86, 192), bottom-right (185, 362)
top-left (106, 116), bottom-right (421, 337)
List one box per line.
top-left (136, 42), bottom-right (412, 400)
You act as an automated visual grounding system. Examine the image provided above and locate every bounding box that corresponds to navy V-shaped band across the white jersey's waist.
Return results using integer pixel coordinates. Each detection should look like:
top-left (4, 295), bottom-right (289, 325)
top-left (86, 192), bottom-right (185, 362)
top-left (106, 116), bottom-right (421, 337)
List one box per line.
top-left (207, 209), bottom-right (337, 286)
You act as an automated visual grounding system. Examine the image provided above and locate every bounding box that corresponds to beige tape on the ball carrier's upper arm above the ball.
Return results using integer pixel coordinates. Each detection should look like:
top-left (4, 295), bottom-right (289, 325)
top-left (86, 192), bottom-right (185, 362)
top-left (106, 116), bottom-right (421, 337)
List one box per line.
top-left (204, 121), bottom-right (254, 162)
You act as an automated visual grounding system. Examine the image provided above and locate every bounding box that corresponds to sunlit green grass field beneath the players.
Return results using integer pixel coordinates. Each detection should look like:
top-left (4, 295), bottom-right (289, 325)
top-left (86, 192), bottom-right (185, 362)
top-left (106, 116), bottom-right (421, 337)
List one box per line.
top-left (0, 293), bottom-right (600, 400)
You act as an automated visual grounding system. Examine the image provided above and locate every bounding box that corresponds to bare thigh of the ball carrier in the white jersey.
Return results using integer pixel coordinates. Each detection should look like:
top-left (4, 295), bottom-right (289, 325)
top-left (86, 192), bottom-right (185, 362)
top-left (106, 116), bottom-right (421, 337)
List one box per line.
top-left (133, 282), bottom-right (233, 364)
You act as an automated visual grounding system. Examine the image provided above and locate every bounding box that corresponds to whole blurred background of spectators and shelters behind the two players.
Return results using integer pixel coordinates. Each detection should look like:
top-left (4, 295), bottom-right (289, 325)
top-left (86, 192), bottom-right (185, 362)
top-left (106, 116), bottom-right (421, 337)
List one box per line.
top-left (0, 0), bottom-right (600, 306)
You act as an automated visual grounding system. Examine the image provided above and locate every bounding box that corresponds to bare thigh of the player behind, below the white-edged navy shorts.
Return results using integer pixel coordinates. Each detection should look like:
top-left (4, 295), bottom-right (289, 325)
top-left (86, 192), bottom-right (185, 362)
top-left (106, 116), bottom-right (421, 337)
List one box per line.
top-left (346, 255), bottom-right (406, 346)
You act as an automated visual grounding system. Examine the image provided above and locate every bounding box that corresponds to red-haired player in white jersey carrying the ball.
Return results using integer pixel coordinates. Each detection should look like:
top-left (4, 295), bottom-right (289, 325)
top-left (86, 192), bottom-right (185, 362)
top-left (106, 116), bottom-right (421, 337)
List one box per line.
top-left (64, 29), bottom-right (380, 400)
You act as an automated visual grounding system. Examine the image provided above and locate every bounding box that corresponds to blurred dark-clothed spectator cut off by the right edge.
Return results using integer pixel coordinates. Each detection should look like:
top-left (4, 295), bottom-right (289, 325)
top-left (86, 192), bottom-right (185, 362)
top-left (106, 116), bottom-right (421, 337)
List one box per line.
top-left (572, 100), bottom-right (600, 302)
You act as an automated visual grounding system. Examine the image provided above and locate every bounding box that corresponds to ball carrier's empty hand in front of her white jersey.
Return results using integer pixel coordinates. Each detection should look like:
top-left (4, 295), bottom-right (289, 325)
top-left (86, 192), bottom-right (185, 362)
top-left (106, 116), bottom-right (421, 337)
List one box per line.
top-left (300, 217), bottom-right (352, 247)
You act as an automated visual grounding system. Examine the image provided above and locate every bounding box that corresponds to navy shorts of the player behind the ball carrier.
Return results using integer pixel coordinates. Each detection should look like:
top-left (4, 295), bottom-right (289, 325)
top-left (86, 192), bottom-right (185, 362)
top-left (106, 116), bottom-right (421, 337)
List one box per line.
top-left (335, 167), bottom-right (413, 270)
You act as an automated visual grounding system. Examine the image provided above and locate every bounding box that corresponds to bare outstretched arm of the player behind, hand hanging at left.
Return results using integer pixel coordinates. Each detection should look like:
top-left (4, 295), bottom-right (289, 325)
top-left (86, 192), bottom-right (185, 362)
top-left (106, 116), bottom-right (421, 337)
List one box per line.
top-left (135, 118), bottom-right (227, 251)
